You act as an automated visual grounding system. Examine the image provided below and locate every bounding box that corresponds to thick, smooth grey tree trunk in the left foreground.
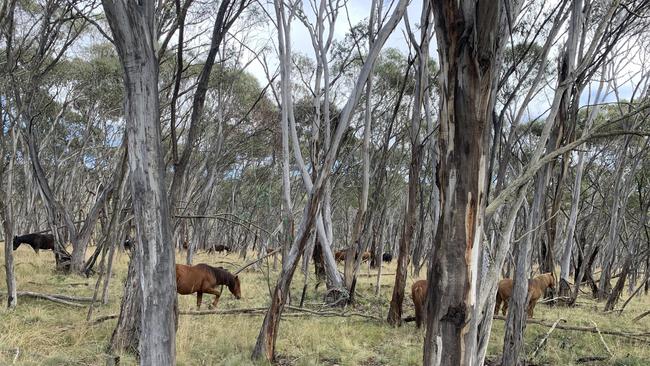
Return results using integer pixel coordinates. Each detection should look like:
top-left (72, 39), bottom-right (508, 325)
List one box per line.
top-left (103, 0), bottom-right (176, 365)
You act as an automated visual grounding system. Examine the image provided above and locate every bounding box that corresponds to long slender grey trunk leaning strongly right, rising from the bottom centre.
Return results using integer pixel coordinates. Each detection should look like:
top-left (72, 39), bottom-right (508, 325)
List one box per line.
top-left (251, 0), bottom-right (408, 361)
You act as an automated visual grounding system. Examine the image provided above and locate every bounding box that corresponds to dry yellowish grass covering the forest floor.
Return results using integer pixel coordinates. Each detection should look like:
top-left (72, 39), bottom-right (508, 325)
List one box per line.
top-left (0, 245), bottom-right (650, 366)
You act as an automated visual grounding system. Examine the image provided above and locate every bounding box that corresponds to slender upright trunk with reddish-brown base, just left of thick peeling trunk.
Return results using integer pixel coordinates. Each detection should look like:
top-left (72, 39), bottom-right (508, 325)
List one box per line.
top-left (387, 1), bottom-right (433, 326)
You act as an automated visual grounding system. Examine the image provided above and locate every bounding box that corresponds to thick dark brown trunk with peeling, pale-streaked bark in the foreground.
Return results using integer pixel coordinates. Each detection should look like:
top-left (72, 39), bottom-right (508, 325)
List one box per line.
top-left (424, 0), bottom-right (505, 365)
